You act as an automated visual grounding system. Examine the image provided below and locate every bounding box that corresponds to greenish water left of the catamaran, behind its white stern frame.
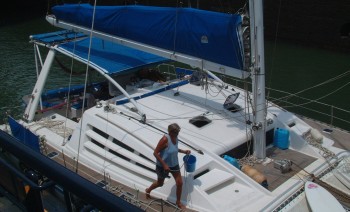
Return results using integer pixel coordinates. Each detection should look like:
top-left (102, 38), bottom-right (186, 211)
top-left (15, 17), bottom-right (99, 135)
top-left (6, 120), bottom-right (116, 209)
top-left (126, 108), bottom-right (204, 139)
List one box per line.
top-left (0, 18), bottom-right (86, 123)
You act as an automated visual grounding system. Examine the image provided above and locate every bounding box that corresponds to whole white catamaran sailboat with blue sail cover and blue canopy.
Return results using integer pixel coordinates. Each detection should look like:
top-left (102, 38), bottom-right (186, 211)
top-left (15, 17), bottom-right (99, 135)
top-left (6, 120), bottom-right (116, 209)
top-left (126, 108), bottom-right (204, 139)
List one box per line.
top-left (0, 0), bottom-right (350, 211)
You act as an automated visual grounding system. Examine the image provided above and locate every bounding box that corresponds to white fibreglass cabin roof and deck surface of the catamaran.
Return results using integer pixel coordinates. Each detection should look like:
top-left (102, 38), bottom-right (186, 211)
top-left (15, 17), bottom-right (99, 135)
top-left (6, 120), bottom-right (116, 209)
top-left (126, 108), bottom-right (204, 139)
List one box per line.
top-left (12, 75), bottom-right (348, 211)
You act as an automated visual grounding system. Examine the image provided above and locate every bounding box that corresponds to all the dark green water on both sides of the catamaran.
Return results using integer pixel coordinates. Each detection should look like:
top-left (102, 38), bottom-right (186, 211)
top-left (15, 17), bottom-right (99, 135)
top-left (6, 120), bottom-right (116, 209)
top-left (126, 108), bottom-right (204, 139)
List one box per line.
top-left (0, 18), bottom-right (350, 130)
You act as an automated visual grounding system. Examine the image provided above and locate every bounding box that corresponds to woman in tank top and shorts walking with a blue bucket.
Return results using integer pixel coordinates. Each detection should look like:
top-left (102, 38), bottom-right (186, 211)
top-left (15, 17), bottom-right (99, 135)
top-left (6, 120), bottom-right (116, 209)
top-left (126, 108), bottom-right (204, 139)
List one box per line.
top-left (146, 123), bottom-right (191, 209)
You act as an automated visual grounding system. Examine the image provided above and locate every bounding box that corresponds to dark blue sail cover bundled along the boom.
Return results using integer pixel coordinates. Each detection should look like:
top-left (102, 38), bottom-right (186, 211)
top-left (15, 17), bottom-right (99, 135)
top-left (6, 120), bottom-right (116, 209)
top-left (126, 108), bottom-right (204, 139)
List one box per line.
top-left (52, 4), bottom-right (243, 70)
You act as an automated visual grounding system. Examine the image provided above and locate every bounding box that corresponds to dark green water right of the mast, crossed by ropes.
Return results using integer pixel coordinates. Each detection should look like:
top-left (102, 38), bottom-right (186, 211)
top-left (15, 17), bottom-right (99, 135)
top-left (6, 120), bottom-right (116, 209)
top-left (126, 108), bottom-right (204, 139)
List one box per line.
top-left (265, 40), bottom-right (350, 130)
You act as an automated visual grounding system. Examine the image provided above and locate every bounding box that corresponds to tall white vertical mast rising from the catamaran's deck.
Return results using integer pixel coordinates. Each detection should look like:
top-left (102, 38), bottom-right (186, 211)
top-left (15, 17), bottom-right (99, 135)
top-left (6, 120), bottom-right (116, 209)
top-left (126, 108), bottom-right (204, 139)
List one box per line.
top-left (249, 0), bottom-right (266, 159)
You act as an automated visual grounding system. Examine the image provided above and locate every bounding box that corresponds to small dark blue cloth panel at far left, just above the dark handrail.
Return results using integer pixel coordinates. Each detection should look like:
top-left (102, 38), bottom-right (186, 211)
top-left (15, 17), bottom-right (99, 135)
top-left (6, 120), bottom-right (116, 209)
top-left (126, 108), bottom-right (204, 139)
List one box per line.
top-left (8, 116), bottom-right (40, 152)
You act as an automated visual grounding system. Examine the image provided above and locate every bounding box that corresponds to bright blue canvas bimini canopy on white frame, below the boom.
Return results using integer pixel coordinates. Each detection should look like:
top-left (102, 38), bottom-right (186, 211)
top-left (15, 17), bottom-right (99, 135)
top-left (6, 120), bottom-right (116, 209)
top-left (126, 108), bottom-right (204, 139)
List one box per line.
top-left (31, 30), bottom-right (168, 75)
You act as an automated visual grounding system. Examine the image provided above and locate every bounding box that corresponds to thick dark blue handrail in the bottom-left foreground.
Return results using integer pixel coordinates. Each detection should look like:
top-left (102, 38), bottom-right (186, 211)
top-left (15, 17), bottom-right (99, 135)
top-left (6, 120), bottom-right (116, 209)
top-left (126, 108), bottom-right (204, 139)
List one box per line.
top-left (0, 130), bottom-right (141, 211)
